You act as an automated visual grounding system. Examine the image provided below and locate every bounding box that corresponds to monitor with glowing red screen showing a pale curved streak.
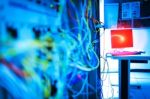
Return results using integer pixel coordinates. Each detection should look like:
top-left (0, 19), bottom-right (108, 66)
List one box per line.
top-left (111, 29), bottom-right (133, 48)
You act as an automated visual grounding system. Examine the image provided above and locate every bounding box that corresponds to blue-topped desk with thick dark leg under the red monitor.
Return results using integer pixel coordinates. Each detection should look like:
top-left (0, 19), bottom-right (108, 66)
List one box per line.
top-left (109, 55), bottom-right (150, 99)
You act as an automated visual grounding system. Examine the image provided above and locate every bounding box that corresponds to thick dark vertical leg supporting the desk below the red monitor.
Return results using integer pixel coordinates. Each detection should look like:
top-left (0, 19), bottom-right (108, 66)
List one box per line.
top-left (119, 60), bottom-right (130, 99)
